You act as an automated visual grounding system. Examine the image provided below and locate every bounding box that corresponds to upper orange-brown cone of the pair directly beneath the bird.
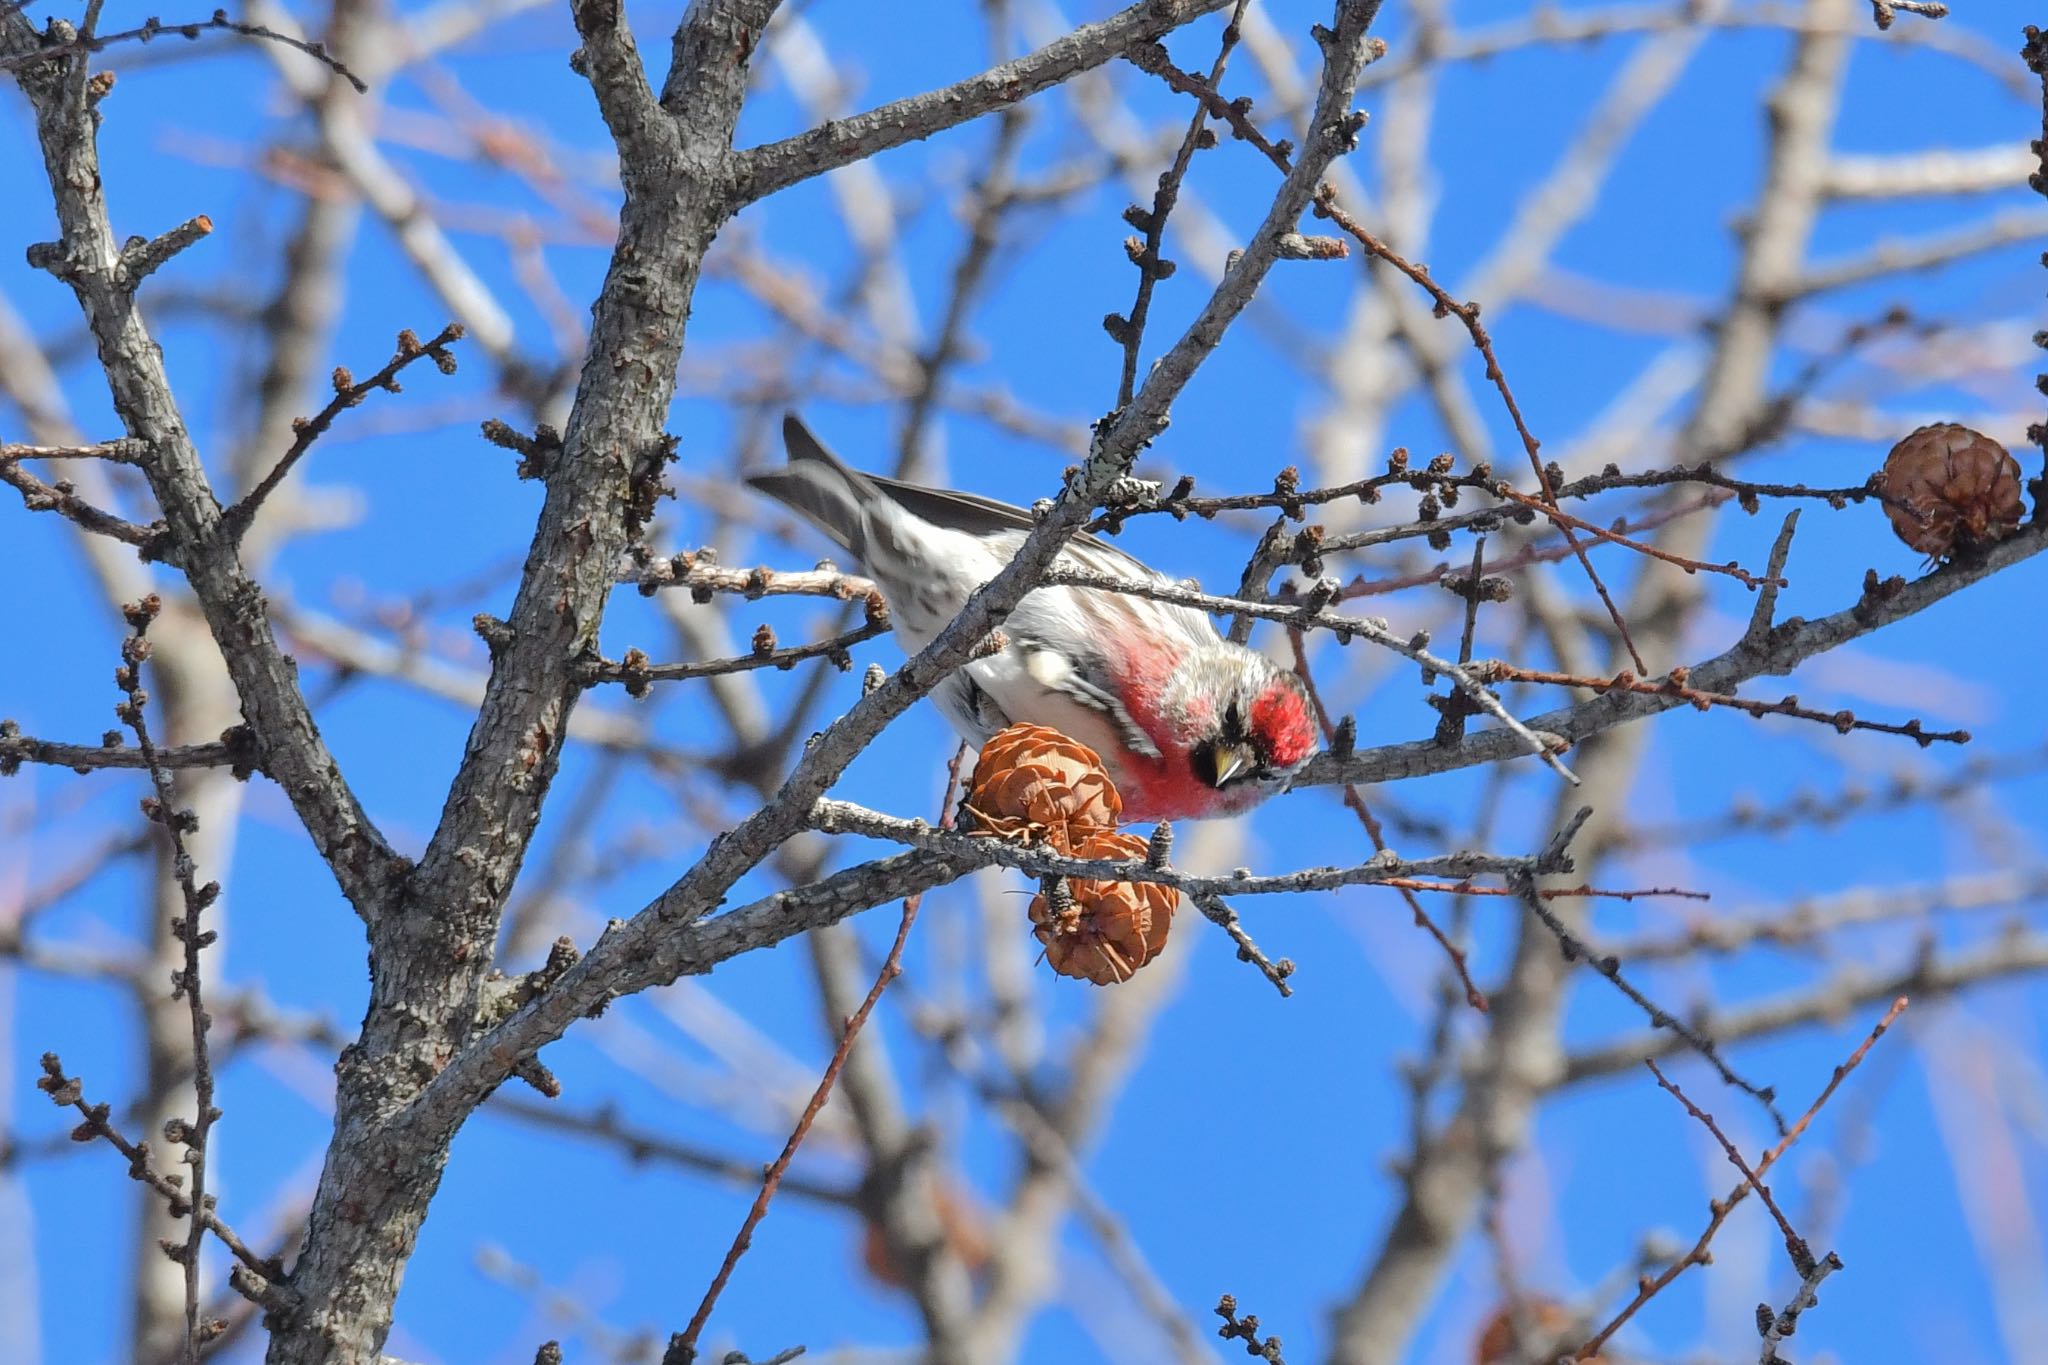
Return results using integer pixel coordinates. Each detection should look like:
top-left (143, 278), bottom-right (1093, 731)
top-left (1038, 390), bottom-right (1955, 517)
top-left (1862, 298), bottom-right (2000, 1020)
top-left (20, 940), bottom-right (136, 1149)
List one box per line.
top-left (967, 724), bottom-right (1124, 853)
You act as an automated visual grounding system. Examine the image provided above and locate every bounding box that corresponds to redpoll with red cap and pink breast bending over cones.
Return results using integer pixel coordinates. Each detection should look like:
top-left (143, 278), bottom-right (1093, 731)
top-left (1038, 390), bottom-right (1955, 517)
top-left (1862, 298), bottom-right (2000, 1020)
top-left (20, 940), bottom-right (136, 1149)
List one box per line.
top-left (748, 415), bottom-right (1315, 821)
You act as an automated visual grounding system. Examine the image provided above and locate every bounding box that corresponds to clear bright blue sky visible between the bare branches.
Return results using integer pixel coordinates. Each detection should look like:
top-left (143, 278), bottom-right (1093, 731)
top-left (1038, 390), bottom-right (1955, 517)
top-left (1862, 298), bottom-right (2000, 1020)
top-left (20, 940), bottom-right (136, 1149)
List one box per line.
top-left (0, 0), bottom-right (2048, 1365)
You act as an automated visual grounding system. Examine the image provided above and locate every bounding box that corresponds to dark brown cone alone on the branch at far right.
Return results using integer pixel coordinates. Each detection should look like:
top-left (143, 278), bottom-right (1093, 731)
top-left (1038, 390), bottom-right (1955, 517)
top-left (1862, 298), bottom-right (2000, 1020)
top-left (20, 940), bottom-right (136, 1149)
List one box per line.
top-left (1876, 422), bottom-right (2028, 559)
